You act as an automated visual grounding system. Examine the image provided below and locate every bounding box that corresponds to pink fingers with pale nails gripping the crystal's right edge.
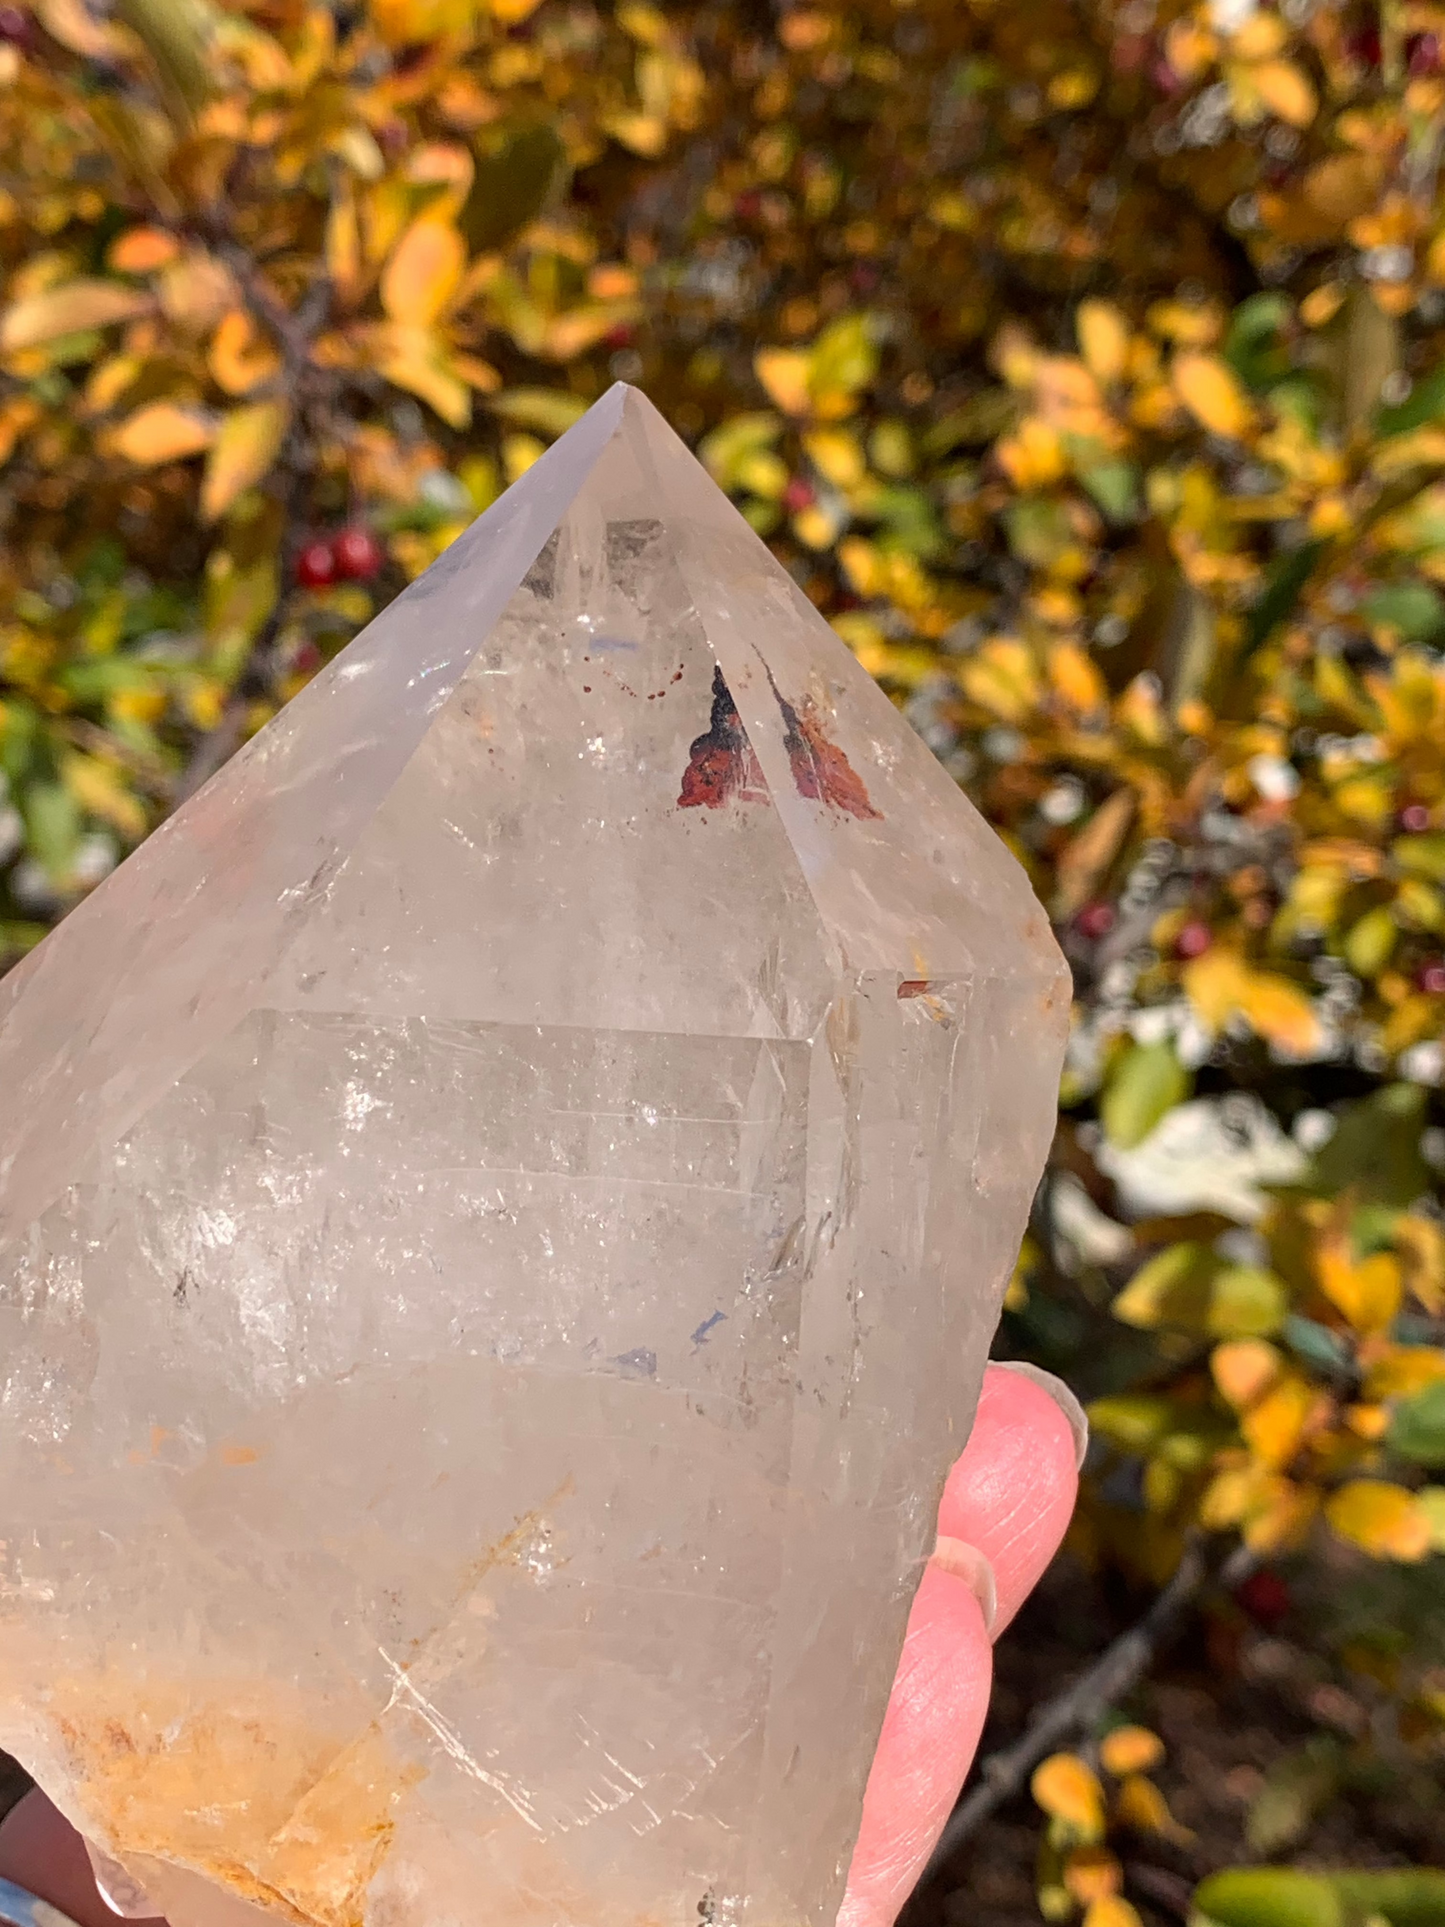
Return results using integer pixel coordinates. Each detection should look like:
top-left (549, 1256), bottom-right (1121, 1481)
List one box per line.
top-left (838, 1364), bottom-right (1087, 1927)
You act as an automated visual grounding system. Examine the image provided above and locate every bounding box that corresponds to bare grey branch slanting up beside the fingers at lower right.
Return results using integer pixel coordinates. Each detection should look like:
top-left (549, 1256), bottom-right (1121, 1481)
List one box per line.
top-left (923, 1542), bottom-right (1258, 1881)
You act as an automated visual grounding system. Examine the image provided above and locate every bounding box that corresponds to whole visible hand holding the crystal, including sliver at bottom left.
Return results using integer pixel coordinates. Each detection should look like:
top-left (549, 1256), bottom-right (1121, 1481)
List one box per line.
top-left (0, 1366), bottom-right (1079, 1927)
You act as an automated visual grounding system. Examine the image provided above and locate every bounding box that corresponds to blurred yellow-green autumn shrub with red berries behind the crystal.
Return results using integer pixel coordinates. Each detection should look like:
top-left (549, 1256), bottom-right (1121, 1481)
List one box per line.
top-left (0, 0), bottom-right (1445, 1927)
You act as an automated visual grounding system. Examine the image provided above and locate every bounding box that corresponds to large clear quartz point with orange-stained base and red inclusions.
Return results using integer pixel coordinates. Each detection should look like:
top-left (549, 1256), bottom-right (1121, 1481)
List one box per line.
top-left (0, 387), bottom-right (1067, 1927)
